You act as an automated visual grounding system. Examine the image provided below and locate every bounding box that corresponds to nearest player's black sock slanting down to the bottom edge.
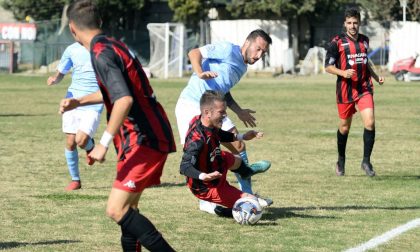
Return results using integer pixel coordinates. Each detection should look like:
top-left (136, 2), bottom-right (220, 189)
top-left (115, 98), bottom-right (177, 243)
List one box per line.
top-left (118, 208), bottom-right (175, 252)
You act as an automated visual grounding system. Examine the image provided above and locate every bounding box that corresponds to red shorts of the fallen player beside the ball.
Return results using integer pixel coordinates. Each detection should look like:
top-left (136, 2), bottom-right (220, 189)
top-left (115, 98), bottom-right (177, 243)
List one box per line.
top-left (195, 151), bottom-right (243, 208)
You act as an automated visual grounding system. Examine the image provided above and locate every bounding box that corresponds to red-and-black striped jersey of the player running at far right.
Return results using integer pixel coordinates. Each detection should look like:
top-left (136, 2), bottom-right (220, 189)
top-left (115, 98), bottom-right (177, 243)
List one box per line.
top-left (325, 34), bottom-right (373, 103)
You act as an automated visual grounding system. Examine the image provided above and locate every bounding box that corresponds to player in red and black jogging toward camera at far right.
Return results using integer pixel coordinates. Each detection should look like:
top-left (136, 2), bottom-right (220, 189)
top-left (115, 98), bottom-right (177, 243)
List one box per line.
top-left (325, 9), bottom-right (385, 177)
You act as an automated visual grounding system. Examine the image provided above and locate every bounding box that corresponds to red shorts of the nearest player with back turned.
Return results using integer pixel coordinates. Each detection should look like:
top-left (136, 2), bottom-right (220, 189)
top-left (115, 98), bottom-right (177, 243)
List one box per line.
top-left (113, 145), bottom-right (168, 193)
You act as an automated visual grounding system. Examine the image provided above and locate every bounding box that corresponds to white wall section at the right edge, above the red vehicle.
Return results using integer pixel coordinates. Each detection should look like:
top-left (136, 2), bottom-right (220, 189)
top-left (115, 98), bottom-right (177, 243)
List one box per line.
top-left (388, 21), bottom-right (420, 71)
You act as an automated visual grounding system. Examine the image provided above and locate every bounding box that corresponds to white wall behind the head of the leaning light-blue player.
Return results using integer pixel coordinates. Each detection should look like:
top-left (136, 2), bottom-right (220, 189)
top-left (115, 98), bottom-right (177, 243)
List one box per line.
top-left (210, 19), bottom-right (289, 70)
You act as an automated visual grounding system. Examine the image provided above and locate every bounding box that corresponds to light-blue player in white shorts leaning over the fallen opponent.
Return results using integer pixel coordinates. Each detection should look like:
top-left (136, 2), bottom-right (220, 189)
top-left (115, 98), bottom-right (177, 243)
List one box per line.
top-left (175, 29), bottom-right (272, 213)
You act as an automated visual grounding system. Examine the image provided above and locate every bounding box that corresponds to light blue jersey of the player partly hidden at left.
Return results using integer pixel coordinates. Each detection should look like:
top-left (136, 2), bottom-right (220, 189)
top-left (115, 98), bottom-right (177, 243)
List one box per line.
top-left (57, 42), bottom-right (103, 113)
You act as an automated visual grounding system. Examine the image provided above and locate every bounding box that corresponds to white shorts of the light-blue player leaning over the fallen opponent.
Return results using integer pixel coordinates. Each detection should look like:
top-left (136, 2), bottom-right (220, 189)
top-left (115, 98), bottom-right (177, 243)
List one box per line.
top-left (175, 99), bottom-right (235, 144)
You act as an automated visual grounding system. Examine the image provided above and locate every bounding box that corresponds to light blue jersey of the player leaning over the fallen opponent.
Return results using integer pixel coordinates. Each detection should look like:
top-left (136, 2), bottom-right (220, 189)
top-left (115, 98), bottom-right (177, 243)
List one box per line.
top-left (180, 42), bottom-right (247, 102)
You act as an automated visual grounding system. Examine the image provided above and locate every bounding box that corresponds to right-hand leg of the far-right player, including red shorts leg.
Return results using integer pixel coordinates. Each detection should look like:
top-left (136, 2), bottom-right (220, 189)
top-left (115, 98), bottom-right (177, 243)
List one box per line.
top-left (357, 95), bottom-right (375, 177)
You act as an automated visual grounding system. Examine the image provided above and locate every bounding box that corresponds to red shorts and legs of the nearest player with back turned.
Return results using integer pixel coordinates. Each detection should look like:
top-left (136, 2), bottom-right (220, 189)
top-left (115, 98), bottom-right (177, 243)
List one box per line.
top-left (107, 146), bottom-right (173, 251)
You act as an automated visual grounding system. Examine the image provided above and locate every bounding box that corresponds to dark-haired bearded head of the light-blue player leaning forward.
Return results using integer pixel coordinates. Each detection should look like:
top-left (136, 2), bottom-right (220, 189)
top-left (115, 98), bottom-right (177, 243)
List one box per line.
top-left (242, 29), bottom-right (272, 65)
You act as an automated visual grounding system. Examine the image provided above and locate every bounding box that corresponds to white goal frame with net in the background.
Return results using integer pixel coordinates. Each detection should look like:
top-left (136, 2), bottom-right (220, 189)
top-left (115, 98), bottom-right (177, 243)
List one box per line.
top-left (147, 23), bottom-right (185, 79)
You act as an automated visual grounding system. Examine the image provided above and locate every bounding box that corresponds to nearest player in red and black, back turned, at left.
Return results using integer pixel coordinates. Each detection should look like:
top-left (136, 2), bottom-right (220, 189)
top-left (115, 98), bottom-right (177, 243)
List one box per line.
top-left (60, 0), bottom-right (176, 251)
